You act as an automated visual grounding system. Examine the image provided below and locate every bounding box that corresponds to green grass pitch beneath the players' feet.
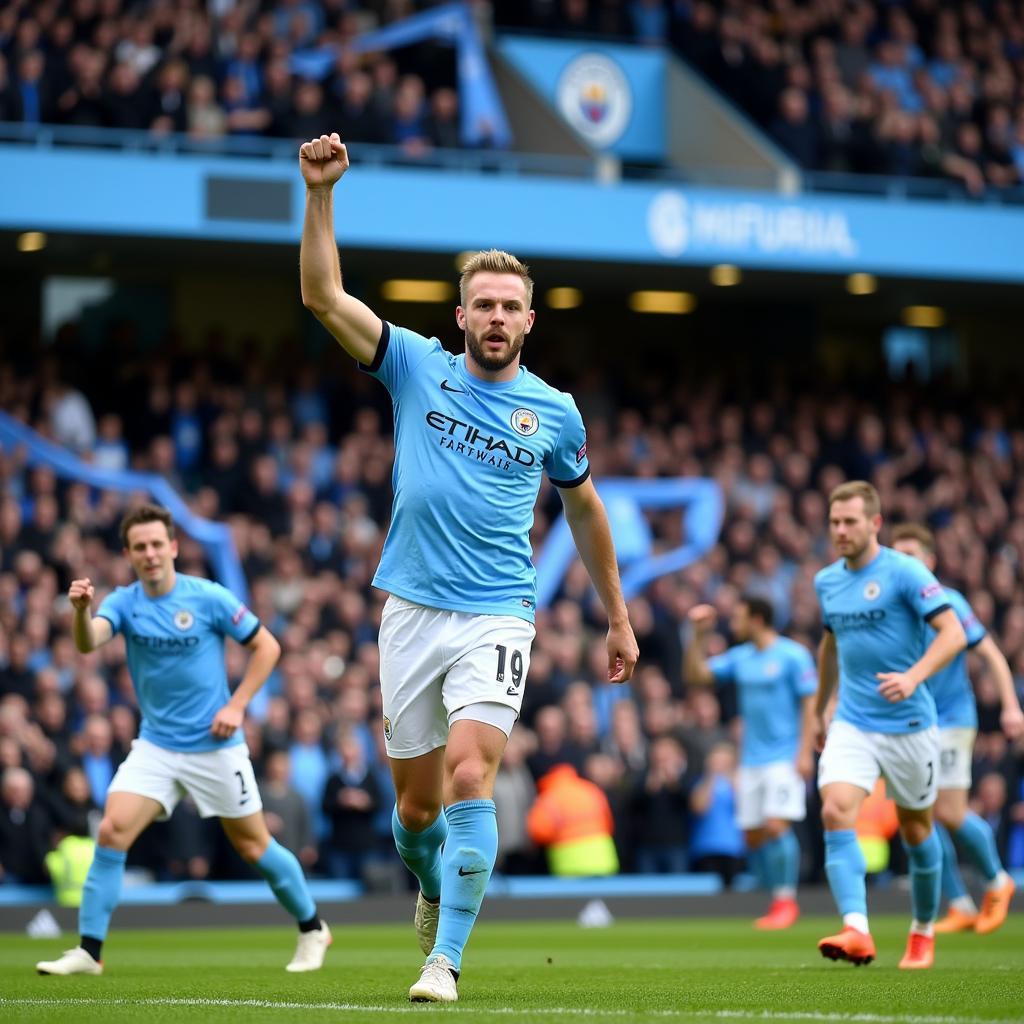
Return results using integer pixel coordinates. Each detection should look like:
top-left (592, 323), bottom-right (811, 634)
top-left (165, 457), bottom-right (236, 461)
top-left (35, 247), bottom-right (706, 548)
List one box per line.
top-left (0, 921), bottom-right (1024, 1024)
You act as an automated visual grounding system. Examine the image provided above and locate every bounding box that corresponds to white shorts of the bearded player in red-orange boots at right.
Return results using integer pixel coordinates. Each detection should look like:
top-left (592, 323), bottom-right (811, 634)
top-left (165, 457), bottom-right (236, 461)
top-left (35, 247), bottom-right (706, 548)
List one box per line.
top-left (818, 721), bottom-right (939, 811)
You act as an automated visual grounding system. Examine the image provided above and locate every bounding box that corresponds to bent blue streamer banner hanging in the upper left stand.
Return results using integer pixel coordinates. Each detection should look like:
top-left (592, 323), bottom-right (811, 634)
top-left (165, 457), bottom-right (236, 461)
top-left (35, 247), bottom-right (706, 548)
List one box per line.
top-left (291, 3), bottom-right (512, 148)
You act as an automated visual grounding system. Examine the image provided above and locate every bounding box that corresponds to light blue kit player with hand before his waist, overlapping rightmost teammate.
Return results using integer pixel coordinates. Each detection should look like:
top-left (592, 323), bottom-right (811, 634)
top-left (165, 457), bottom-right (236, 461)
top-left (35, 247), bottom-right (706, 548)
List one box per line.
top-left (814, 480), bottom-right (967, 969)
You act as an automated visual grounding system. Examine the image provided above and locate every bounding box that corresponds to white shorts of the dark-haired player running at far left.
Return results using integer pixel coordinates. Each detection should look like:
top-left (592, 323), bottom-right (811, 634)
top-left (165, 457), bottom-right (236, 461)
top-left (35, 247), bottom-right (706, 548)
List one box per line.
top-left (106, 739), bottom-right (263, 821)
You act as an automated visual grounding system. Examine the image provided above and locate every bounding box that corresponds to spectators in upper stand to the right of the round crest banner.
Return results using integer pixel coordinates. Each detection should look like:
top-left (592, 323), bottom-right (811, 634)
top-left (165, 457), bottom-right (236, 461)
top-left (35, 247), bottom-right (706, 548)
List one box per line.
top-left (495, 0), bottom-right (1024, 196)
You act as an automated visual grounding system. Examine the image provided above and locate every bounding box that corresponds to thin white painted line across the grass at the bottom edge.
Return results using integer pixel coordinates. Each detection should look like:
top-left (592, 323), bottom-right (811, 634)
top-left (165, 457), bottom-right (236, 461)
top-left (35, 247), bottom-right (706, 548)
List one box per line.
top-left (0, 996), bottom-right (1020, 1024)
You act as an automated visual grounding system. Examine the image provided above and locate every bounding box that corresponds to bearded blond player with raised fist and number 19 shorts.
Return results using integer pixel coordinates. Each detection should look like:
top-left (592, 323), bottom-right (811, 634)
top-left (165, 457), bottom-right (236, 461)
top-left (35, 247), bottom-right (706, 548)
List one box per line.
top-left (299, 135), bottom-right (638, 1002)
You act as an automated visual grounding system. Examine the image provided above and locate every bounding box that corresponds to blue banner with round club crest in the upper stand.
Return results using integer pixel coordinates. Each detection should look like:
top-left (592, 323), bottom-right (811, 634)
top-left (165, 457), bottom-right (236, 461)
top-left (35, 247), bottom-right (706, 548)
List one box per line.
top-left (498, 36), bottom-right (666, 162)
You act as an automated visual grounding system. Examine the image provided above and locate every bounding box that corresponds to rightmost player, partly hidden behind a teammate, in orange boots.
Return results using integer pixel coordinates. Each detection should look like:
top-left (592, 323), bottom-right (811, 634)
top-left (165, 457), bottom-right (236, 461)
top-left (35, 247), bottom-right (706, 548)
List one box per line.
top-left (892, 522), bottom-right (1024, 935)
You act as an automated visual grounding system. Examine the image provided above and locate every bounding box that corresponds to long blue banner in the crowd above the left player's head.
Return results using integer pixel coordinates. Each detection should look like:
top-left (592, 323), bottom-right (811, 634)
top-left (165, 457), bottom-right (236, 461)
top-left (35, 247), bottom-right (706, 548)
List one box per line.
top-left (0, 412), bottom-right (249, 601)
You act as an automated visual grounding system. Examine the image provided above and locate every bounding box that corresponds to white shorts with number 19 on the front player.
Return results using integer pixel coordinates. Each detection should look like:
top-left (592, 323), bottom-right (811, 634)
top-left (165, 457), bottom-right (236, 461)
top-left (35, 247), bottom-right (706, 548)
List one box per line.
top-left (378, 594), bottom-right (536, 758)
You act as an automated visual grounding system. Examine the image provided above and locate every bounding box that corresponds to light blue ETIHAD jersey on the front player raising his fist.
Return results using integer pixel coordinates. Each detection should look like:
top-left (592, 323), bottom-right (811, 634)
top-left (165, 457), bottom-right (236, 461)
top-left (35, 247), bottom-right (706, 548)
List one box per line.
top-left (362, 323), bottom-right (590, 622)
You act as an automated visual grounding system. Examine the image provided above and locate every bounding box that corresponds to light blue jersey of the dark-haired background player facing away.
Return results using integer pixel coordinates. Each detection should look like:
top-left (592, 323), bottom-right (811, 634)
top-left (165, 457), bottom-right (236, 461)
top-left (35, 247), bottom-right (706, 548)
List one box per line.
top-left (708, 637), bottom-right (818, 768)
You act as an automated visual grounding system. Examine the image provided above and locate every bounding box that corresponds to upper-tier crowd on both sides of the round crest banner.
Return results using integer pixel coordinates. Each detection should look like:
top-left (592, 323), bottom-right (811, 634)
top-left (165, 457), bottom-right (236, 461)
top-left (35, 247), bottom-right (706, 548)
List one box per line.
top-left (0, 0), bottom-right (1024, 196)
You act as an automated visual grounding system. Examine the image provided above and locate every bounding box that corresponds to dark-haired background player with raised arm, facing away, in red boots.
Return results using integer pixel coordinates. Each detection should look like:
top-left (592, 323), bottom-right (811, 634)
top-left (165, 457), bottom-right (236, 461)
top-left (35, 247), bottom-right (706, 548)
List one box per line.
top-left (685, 597), bottom-right (817, 931)
